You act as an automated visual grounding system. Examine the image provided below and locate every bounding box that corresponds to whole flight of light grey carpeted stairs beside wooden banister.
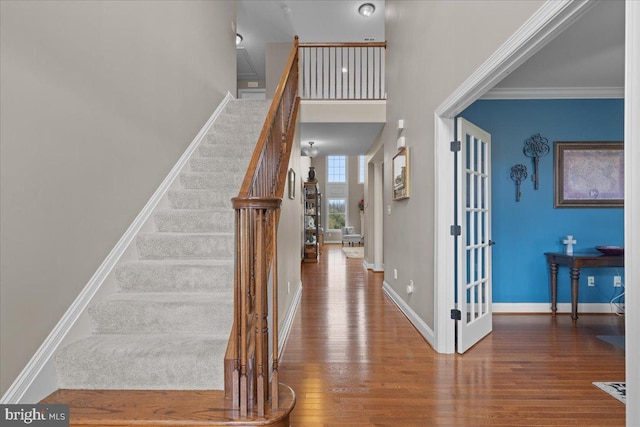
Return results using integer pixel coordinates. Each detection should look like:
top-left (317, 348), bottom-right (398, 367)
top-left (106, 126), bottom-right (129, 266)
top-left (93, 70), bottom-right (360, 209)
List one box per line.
top-left (55, 100), bottom-right (270, 390)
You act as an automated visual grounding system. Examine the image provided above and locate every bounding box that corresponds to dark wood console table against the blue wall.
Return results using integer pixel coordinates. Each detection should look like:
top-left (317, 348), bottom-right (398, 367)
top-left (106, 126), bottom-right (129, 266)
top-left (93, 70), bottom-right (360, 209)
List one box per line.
top-left (545, 252), bottom-right (624, 322)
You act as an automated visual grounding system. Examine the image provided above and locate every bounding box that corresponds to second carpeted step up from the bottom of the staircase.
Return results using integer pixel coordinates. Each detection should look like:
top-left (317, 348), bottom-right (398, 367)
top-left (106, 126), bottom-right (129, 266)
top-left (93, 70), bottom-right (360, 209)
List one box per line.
top-left (89, 288), bottom-right (233, 339)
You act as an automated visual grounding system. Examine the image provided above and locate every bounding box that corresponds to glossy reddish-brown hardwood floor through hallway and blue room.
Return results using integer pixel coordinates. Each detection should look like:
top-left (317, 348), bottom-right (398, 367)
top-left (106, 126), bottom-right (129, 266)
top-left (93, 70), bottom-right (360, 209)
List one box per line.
top-left (280, 245), bottom-right (625, 427)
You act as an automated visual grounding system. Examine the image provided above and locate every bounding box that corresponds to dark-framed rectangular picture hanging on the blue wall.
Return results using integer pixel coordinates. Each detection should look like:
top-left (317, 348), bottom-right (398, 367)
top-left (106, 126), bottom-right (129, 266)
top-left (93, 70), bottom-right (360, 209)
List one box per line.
top-left (554, 141), bottom-right (624, 208)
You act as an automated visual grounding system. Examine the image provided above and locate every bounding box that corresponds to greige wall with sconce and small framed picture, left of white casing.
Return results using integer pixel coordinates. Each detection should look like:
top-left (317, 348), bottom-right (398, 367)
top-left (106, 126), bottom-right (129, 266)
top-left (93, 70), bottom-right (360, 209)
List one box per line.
top-left (380, 0), bottom-right (543, 329)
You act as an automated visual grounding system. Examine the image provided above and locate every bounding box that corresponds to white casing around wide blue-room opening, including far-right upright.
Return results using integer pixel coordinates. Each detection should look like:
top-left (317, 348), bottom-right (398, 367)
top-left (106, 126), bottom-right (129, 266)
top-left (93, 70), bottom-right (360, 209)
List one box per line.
top-left (433, 0), bottom-right (640, 420)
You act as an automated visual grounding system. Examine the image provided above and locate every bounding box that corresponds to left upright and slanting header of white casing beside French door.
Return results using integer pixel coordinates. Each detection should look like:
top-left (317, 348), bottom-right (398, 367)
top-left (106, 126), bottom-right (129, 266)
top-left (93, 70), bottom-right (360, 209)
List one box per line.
top-left (433, 0), bottom-right (604, 354)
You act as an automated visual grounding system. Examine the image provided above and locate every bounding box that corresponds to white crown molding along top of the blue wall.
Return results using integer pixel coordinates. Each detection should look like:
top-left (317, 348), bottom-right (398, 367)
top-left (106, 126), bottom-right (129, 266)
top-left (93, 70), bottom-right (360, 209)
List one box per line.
top-left (480, 87), bottom-right (624, 99)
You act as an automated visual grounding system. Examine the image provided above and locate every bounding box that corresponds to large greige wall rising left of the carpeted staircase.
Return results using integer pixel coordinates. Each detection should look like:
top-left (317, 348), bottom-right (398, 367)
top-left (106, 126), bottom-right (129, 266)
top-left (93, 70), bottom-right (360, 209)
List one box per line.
top-left (0, 0), bottom-right (236, 395)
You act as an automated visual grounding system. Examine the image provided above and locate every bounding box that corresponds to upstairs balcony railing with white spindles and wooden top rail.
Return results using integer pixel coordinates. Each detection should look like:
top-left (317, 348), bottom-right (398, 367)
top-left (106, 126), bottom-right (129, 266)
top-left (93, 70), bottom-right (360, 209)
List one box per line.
top-left (299, 42), bottom-right (387, 100)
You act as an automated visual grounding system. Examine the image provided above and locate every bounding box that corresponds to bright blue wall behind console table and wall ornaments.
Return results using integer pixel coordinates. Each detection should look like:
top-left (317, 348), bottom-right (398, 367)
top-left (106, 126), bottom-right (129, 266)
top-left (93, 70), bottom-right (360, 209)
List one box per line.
top-left (460, 99), bottom-right (624, 303)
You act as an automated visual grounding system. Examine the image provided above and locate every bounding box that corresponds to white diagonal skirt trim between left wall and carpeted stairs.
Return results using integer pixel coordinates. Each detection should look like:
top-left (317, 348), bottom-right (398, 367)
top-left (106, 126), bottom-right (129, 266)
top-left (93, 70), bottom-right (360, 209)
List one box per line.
top-left (0, 92), bottom-right (233, 404)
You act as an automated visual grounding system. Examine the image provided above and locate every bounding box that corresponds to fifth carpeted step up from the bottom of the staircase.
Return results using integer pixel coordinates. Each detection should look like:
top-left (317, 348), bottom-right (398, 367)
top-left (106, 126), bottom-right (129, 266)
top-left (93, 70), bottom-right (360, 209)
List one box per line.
top-left (153, 209), bottom-right (234, 233)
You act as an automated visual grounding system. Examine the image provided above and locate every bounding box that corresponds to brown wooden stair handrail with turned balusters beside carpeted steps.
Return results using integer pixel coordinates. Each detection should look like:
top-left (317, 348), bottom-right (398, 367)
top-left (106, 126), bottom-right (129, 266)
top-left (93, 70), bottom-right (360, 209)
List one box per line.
top-left (225, 36), bottom-right (300, 417)
